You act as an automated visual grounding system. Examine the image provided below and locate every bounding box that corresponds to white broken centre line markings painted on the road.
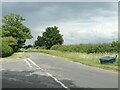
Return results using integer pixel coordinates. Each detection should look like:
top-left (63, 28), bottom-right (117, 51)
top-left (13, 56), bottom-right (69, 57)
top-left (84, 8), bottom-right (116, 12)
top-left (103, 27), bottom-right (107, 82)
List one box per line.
top-left (25, 58), bottom-right (70, 90)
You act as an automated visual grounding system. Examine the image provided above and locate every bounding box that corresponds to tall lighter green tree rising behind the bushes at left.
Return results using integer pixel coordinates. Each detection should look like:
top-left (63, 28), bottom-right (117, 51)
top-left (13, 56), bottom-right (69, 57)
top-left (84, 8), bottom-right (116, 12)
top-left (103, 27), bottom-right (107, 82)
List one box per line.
top-left (2, 14), bottom-right (32, 48)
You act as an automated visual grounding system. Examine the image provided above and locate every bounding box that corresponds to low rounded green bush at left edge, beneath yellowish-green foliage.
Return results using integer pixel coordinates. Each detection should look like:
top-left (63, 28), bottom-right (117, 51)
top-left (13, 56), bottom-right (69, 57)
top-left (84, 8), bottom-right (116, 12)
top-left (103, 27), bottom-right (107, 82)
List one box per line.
top-left (0, 43), bottom-right (14, 57)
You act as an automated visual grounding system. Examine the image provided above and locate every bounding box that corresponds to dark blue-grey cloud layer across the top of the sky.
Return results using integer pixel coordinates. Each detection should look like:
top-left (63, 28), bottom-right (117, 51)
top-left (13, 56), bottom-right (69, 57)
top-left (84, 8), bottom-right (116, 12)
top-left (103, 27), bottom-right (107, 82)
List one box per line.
top-left (3, 2), bottom-right (117, 27)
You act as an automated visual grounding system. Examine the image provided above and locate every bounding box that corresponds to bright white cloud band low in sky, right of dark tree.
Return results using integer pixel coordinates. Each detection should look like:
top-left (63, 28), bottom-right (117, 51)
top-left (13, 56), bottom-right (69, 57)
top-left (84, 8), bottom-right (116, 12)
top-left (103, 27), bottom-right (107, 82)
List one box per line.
top-left (26, 17), bottom-right (118, 44)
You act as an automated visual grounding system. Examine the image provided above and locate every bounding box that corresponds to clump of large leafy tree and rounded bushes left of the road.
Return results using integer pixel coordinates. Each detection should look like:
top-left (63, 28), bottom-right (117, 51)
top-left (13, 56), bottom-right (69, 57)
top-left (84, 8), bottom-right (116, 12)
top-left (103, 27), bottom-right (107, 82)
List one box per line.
top-left (0, 14), bottom-right (32, 57)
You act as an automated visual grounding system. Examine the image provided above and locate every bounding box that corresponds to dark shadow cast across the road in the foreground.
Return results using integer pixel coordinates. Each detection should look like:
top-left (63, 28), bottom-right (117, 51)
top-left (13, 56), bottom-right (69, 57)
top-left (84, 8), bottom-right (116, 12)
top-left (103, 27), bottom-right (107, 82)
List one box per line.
top-left (2, 70), bottom-right (117, 90)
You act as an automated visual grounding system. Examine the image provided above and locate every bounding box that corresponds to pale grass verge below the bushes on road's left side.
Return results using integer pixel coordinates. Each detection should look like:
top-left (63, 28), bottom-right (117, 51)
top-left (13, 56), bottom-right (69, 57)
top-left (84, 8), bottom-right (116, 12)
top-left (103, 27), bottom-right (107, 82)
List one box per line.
top-left (0, 52), bottom-right (29, 60)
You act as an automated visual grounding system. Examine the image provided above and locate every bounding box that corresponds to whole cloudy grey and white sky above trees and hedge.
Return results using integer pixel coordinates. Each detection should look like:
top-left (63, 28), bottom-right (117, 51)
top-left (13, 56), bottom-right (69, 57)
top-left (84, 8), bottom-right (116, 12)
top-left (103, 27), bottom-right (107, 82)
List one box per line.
top-left (2, 2), bottom-right (118, 44)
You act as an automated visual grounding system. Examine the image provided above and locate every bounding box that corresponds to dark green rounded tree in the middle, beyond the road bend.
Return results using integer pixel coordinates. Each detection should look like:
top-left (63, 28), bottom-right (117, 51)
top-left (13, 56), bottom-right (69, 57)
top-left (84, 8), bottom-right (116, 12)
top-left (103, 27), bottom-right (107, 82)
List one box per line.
top-left (35, 26), bottom-right (63, 49)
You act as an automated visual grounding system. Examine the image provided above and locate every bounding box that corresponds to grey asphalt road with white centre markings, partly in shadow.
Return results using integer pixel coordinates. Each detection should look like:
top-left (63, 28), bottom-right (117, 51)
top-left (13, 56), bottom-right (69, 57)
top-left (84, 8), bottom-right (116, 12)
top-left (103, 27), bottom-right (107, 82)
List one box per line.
top-left (0, 52), bottom-right (118, 89)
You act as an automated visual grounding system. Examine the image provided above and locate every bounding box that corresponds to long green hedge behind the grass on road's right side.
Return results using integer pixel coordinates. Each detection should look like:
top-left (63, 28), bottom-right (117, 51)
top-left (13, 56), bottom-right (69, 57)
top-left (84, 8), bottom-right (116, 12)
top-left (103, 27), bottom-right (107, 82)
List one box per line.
top-left (51, 41), bottom-right (118, 54)
